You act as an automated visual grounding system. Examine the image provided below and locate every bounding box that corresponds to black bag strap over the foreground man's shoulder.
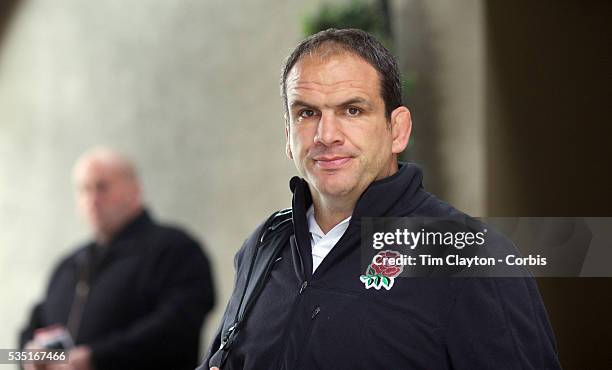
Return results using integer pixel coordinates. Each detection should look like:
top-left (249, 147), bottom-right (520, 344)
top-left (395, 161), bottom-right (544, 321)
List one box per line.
top-left (209, 208), bottom-right (292, 368)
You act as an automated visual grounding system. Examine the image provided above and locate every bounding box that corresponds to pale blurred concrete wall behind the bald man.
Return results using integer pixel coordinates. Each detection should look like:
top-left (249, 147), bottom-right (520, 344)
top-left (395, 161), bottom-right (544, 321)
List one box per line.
top-left (0, 0), bottom-right (326, 358)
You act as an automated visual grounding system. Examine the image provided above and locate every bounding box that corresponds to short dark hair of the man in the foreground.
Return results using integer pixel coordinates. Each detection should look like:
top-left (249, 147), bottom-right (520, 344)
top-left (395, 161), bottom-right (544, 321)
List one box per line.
top-left (280, 28), bottom-right (402, 119)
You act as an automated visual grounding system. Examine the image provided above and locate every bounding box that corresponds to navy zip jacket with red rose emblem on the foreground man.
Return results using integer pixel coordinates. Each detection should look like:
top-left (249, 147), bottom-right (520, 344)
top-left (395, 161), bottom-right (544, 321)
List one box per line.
top-left (199, 164), bottom-right (559, 370)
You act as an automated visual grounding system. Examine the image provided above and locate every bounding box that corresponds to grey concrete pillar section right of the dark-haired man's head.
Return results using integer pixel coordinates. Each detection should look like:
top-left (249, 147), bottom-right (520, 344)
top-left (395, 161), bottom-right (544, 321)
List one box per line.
top-left (392, 0), bottom-right (486, 216)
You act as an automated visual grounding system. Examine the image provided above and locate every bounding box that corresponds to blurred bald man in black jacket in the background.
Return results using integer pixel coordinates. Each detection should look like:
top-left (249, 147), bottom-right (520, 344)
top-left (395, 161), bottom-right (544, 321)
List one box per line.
top-left (21, 148), bottom-right (214, 370)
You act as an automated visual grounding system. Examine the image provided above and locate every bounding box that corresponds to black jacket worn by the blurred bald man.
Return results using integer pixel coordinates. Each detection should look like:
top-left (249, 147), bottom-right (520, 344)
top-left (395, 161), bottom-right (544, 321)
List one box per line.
top-left (21, 211), bottom-right (214, 370)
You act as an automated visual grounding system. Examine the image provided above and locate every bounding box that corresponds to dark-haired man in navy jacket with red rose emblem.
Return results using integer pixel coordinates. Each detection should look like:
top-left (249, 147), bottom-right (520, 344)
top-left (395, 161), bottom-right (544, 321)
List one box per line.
top-left (199, 29), bottom-right (559, 370)
